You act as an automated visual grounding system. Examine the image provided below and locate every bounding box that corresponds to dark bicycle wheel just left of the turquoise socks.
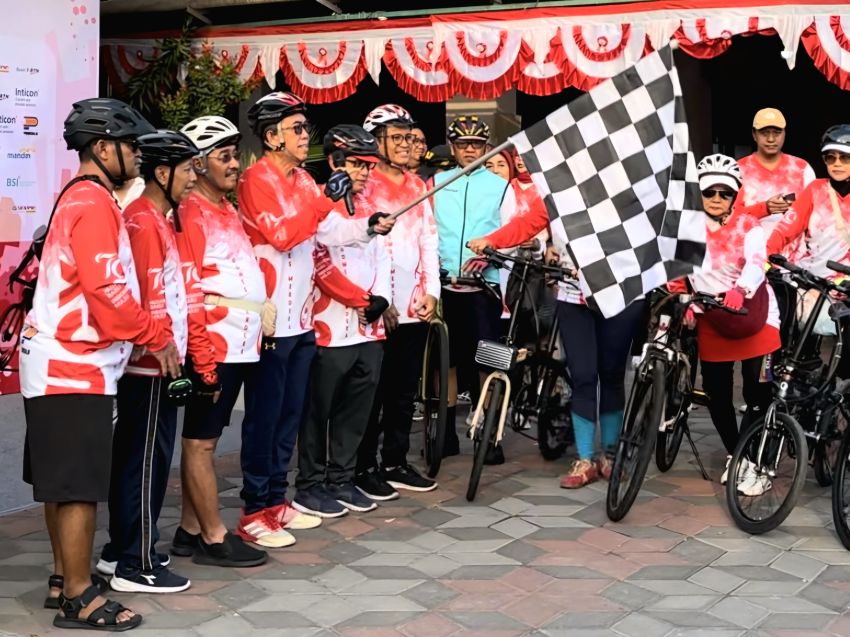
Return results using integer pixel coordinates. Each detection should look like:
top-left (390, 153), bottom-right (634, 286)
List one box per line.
top-left (537, 361), bottom-right (573, 460)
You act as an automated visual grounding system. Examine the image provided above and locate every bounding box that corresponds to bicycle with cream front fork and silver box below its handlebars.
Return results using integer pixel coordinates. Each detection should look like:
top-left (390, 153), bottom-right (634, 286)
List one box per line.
top-left (460, 248), bottom-right (571, 502)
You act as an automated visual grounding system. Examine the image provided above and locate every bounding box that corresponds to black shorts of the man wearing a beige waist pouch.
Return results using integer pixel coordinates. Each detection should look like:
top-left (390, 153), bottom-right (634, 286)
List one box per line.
top-left (183, 363), bottom-right (252, 440)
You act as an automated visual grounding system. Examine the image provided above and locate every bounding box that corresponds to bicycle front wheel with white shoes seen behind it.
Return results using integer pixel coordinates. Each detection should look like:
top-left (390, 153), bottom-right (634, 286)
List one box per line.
top-left (726, 412), bottom-right (808, 535)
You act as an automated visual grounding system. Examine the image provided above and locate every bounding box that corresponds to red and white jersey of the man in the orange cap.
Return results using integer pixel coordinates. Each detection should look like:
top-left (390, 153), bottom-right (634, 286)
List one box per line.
top-left (736, 153), bottom-right (815, 233)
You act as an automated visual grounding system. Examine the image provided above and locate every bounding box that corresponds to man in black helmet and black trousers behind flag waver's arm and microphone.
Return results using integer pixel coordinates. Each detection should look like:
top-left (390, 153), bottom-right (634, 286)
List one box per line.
top-left (293, 125), bottom-right (390, 518)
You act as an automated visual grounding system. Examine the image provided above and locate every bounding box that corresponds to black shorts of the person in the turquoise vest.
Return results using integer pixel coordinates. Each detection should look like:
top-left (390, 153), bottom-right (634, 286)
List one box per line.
top-left (441, 288), bottom-right (502, 367)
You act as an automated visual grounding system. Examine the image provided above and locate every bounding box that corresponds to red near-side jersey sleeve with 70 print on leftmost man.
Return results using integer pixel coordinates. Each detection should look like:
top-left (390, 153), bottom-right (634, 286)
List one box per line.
top-left (69, 206), bottom-right (171, 352)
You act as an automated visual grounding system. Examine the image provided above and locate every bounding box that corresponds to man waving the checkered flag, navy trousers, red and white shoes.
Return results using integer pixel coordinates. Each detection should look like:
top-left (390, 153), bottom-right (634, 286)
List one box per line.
top-left (239, 92), bottom-right (393, 543)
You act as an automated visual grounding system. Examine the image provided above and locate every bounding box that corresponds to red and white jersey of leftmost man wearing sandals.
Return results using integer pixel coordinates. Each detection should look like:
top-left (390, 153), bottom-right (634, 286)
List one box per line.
top-left (21, 181), bottom-right (170, 398)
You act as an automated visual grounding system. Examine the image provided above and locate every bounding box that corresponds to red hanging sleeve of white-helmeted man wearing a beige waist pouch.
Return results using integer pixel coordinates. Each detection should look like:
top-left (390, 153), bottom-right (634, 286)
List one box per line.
top-left (177, 210), bottom-right (216, 384)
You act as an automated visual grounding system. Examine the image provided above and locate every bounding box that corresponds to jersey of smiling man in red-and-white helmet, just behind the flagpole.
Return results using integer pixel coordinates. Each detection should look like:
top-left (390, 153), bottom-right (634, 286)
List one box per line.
top-left (362, 169), bottom-right (440, 323)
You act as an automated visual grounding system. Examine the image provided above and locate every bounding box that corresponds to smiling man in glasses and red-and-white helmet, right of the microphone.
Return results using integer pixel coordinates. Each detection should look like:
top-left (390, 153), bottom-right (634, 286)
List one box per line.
top-left (355, 104), bottom-right (440, 501)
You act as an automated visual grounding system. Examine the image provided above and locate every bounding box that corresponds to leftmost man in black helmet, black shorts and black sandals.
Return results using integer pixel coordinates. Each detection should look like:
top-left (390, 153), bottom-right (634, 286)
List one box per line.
top-left (20, 98), bottom-right (180, 630)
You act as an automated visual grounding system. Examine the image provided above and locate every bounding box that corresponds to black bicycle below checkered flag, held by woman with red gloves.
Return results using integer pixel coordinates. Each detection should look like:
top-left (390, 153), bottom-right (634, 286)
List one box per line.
top-left (605, 290), bottom-right (746, 522)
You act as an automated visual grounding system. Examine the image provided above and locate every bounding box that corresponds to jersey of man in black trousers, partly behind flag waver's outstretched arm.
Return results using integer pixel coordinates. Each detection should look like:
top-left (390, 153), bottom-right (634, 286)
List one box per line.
top-left (313, 199), bottom-right (395, 347)
